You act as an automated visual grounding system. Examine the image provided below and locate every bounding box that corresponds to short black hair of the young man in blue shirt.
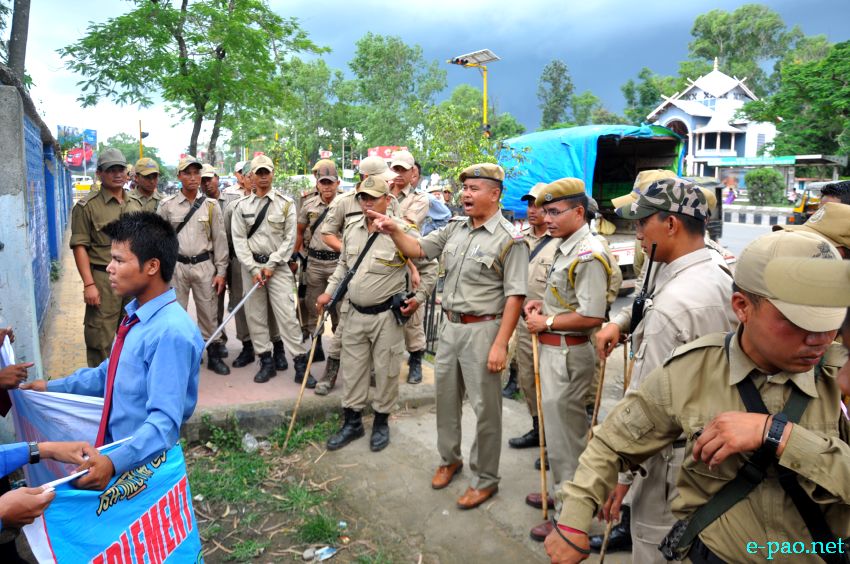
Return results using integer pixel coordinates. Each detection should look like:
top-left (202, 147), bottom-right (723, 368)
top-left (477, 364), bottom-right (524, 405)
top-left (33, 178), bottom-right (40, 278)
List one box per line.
top-left (103, 212), bottom-right (177, 282)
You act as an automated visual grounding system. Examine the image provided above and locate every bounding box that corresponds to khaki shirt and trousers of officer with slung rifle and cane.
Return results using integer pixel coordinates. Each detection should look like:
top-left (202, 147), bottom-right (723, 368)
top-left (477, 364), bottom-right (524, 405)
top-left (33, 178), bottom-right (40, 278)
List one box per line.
top-left (325, 215), bottom-right (436, 413)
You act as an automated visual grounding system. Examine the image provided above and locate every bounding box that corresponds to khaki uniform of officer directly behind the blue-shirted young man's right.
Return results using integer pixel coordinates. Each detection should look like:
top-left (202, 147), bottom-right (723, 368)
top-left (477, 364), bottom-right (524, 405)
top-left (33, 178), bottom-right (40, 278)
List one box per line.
top-left (157, 190), bottom-right (229, 342)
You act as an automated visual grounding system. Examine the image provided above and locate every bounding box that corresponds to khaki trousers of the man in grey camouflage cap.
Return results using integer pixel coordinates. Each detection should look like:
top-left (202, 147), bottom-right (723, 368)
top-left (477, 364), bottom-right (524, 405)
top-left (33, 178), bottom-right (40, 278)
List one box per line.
top-left (630, 445), bottom-right (685, 564)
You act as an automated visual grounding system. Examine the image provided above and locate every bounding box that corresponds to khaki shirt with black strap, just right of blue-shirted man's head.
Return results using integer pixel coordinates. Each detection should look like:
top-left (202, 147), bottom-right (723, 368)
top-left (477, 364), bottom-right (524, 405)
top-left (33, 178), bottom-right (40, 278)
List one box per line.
top-left (157, 190), bottom-right (229, 276)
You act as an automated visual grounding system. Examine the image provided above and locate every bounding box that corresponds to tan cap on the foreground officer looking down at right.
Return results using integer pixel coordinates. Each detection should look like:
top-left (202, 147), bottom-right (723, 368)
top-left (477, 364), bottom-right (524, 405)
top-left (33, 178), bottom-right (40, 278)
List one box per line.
top-left (735, 231), bottom-right (847, 332)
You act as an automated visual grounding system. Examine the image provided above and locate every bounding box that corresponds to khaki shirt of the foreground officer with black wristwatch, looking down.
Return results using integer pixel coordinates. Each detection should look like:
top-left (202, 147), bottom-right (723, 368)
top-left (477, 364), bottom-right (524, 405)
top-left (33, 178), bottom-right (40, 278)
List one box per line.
top-left (559, 329), bottom-right (850, 563)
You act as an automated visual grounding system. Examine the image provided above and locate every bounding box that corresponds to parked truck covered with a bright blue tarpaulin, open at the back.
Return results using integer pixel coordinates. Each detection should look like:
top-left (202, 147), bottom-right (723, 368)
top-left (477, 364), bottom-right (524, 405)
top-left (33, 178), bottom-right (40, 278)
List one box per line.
top-left (499, 125), bottom-right (735, 292)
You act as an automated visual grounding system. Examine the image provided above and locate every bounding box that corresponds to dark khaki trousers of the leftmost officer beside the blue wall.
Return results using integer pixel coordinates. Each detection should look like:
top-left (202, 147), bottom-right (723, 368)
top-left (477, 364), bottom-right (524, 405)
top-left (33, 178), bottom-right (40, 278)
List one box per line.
top-left (83, 269), bottom-right (129, 368)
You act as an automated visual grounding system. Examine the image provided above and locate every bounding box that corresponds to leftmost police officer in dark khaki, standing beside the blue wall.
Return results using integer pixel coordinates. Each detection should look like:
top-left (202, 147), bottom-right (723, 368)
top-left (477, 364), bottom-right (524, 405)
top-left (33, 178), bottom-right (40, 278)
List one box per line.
top-left (71, 147), bottom-right (127, 367)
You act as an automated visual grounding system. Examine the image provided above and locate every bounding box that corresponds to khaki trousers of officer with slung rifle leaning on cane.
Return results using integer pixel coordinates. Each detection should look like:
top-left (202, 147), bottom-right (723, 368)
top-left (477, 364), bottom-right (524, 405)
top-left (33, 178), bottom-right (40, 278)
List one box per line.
top-left (340, 307), bottom-right (404, 413)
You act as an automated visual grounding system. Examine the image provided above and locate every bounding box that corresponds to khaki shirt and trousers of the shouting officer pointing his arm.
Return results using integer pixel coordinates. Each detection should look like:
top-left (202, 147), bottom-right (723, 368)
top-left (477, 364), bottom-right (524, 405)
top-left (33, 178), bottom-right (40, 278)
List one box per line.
top-left (420, 212), bottom-right (528, 490)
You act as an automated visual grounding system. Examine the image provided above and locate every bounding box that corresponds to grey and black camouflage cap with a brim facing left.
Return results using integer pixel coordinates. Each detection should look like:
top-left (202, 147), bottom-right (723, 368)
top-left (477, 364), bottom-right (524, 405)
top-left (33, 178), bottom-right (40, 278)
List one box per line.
top-left (617, 178), bottom-right (708, 221)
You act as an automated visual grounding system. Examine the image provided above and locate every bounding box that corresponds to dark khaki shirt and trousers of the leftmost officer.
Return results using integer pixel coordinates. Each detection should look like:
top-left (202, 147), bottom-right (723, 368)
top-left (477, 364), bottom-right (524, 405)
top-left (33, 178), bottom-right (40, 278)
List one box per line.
top-left (70, 189), bottom-right (126, 367)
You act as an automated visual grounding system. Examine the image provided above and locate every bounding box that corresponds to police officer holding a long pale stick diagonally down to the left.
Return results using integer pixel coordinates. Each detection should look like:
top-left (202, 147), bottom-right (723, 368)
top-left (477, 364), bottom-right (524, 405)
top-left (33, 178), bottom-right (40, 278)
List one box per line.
top-left (231, 155), bottom-right (315, 386)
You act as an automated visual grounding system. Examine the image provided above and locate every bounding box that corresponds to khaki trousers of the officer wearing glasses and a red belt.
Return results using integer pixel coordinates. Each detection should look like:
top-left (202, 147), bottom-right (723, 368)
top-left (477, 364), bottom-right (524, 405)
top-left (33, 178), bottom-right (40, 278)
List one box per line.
top-left (540, 342), bottom-right (594, 492)
